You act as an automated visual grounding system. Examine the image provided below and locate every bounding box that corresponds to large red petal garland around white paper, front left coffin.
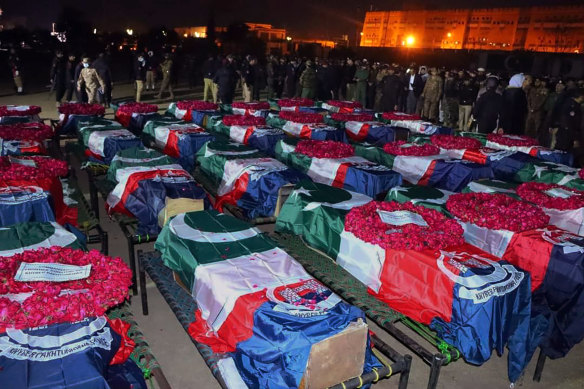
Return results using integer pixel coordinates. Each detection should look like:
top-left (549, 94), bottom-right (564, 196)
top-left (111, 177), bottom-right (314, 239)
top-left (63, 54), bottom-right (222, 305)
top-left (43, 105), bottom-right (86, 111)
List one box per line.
top-left (0, 246), bottom-right (132, 331)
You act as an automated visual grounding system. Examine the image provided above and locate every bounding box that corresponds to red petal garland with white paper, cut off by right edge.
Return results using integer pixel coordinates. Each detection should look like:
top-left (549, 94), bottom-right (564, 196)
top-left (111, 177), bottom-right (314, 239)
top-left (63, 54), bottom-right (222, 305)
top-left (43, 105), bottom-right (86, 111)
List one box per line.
top-left (517, 182), bottom-right (584, 211)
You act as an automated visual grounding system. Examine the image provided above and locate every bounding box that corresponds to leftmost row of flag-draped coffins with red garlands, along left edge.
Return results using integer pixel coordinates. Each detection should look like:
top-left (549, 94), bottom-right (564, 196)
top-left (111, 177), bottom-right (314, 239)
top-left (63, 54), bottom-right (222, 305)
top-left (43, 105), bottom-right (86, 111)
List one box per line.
top-left (0, 104), bottom-right (155, 389)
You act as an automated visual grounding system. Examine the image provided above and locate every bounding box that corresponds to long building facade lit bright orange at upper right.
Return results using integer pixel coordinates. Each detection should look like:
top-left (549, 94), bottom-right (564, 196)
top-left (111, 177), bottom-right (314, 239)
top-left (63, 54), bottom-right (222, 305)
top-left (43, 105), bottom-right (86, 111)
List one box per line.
top-left (360, 5), bottom-right (584, 53)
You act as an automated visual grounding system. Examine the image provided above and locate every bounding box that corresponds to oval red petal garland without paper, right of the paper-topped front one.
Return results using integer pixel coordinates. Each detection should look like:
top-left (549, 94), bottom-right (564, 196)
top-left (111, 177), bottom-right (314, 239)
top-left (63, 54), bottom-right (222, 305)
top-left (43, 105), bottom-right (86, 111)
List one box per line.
top-left (446, 193), bottom-right (550, 232)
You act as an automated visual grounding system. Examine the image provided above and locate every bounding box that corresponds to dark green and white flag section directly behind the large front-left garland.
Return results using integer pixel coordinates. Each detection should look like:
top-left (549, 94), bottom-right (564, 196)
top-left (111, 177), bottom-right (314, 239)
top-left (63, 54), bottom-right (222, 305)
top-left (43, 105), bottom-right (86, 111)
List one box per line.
top-left (0, 222), bottom-right (85, 257)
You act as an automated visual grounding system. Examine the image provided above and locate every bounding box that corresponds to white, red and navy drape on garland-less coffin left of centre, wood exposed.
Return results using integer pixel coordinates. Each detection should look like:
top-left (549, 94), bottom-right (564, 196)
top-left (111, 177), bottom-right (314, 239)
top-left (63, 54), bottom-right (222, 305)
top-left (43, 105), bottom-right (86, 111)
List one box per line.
top-left (106, 165), bottom-right (207, 235)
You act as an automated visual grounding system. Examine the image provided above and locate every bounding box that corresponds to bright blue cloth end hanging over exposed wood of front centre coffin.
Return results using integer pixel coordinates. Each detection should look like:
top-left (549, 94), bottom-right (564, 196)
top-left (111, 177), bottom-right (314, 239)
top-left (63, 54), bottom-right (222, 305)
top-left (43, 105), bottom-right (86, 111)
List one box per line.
top-left (233, 302), bottom-right (382, 389)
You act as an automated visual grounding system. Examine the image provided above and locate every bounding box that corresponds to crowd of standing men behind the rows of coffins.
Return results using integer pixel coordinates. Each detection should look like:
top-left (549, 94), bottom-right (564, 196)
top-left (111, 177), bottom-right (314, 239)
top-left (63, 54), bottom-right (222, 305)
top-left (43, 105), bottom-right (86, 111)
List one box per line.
top-left (41, 51), bottom-right (584, 156)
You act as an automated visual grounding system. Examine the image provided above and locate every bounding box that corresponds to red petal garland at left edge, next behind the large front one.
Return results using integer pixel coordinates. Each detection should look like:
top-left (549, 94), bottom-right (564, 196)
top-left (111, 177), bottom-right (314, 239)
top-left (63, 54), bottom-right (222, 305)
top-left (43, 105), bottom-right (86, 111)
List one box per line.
top-left (0, 155), bottom-right (69, 181)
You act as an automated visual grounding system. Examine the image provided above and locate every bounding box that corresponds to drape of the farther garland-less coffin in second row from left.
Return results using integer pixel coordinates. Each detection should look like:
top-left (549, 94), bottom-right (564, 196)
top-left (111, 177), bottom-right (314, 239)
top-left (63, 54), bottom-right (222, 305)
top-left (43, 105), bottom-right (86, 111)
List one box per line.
top-left (81, 127), bottom-right (142, 165)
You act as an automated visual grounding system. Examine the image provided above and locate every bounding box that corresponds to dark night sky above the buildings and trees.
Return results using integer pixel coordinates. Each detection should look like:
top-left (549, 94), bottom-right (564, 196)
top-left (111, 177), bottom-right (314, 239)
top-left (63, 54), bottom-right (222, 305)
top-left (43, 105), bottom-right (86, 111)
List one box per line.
top-left (0, 0), bottom-right (582, 38)
